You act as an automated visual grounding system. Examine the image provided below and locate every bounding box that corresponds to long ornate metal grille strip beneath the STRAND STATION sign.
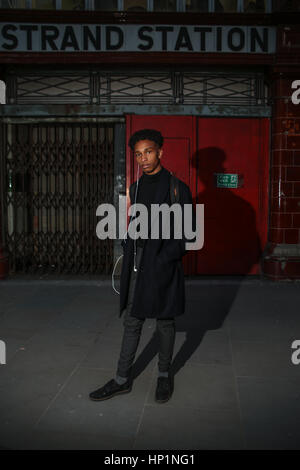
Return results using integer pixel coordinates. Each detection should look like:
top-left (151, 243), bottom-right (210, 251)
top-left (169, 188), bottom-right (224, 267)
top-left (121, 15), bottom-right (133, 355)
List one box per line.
top-left (7, 71), bottom-right (268, 106)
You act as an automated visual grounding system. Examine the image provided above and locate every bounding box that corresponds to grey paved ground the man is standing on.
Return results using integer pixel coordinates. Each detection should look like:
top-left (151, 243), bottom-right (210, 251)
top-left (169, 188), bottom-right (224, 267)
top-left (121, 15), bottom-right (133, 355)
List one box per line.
top-left (0, 277), bottom-right (300, 450)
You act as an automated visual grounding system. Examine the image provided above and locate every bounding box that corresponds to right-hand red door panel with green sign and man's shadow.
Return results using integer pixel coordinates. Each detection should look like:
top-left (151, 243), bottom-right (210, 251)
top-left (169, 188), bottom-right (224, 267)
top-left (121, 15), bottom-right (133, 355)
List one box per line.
top-left (194, 118), bottom-right (269, 274)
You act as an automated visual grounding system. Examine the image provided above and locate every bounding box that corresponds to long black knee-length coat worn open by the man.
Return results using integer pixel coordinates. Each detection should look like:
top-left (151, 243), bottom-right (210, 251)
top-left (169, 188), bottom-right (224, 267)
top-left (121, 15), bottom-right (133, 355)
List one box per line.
top-left (119, 168), bottom-right (192, 318)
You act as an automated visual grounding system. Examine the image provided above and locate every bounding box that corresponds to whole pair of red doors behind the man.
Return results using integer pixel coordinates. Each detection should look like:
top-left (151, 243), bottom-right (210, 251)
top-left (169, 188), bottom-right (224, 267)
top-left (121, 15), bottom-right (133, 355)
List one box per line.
top-left (126, 115), bottom-right (269, 274)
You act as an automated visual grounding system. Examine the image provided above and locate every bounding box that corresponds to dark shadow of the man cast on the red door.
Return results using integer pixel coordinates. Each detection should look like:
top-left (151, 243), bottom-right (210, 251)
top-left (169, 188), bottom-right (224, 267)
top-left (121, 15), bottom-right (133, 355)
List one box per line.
top-left (192, 147), bottom-right (262, 275)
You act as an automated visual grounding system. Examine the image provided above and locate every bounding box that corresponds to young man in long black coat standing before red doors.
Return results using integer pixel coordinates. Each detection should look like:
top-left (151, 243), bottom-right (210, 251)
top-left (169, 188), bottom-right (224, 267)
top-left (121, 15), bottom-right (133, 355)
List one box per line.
top-left (89, 129), bottom-right (192, 403)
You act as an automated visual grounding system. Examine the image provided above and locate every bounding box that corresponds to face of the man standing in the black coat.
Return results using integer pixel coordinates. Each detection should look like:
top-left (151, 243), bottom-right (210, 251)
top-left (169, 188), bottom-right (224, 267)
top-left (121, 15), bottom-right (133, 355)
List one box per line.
top-left (134, 140), bottom-right (163, 175)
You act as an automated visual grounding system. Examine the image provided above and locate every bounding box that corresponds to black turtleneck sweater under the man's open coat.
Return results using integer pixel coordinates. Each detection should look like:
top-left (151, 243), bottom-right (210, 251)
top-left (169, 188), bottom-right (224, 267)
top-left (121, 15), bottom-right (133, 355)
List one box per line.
top-left (137, 167), bottom-right (166, 247)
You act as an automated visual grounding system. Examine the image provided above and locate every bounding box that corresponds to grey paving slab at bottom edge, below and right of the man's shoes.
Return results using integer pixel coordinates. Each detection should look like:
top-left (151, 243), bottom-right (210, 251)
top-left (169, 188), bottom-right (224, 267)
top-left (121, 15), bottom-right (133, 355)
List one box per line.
top-left (134, 403), bottom-right (244, 450)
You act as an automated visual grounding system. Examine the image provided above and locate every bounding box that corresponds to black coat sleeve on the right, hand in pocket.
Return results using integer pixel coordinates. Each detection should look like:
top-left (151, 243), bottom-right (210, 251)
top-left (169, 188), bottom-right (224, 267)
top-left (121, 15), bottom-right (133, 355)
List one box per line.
top-left (159, 182), bottom-right (196, 262)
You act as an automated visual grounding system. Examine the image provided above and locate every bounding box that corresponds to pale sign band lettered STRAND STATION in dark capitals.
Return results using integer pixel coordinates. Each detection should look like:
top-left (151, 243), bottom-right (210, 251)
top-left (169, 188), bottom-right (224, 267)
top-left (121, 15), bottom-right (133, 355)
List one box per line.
top-left (0, 23), bottom-right (276, 54)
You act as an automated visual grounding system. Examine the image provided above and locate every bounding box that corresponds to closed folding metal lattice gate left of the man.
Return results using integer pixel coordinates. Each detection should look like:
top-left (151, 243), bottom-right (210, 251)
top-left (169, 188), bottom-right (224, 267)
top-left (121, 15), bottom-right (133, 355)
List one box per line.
top-left (2, 123), bottom-right (114, 274)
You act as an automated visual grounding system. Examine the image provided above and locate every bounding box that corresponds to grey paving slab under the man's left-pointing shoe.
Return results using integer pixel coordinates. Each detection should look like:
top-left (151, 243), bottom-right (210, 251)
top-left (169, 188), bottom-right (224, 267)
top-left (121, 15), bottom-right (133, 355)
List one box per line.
top-left (36, 367), bottom-right (155, 449)
